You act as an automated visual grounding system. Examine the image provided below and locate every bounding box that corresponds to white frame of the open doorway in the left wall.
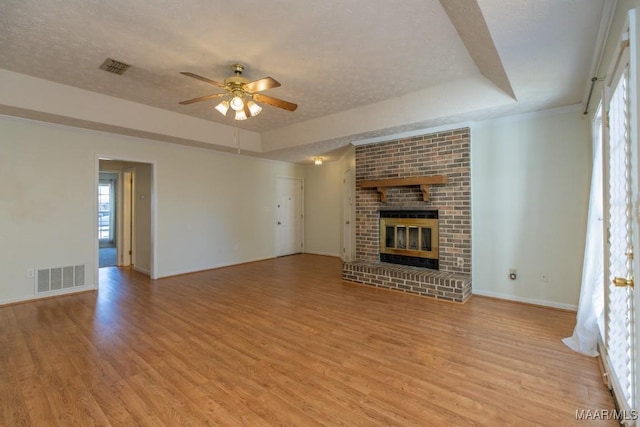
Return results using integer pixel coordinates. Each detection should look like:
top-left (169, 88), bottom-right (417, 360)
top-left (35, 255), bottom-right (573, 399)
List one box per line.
top-left (92, 153), bottom-right (158, 288)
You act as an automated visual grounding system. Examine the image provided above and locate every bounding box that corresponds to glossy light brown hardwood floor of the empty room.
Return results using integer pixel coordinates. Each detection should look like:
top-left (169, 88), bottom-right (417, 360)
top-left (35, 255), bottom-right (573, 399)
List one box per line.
top-left (0, 255), bottom-right (617, 426)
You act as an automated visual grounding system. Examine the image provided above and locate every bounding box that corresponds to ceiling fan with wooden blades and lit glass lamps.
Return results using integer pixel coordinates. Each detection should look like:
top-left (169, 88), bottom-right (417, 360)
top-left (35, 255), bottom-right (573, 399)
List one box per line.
top-left (180, 64), bottom-right (298, 120)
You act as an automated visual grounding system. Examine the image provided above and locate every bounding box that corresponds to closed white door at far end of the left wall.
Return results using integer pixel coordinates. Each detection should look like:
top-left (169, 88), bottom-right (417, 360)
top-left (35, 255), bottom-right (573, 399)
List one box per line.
top-left (276, 178), bottom-right (304, 256)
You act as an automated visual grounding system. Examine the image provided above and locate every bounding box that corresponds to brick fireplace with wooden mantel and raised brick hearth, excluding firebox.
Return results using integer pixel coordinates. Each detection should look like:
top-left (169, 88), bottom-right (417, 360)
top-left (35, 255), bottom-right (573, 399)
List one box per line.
top-left (342, 128), bottom-right (471, 302)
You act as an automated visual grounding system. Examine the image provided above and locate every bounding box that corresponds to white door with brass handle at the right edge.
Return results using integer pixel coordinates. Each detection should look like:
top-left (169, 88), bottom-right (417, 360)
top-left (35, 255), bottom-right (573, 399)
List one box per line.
top-left (604, 11), bottom-right (640, 421)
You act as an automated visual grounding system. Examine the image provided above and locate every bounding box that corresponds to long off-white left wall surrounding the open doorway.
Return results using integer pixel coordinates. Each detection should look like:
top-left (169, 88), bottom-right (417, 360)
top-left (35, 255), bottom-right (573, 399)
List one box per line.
top-left (0, 117), bottom-right (304, 304)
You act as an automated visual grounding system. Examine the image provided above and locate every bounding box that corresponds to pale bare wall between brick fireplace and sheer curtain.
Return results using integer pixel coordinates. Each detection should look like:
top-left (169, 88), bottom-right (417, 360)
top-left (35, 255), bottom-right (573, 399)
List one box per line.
top-left (471, 109), bottom-right (591, 309)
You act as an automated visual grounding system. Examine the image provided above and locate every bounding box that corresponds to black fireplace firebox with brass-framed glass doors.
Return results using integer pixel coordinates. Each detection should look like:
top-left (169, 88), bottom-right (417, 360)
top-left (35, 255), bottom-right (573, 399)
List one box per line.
top-left (380, 210), bottom-right (439, 270)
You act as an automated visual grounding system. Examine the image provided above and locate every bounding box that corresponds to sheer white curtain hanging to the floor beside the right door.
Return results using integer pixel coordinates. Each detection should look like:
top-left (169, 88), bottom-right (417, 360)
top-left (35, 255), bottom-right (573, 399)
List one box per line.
top-left (562, 109), bottom-right (604, 356)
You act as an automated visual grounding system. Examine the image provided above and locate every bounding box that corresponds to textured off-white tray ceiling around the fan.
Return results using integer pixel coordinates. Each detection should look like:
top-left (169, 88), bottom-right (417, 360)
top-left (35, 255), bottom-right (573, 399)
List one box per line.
top-left (0, 0), bottom-right (605, 161)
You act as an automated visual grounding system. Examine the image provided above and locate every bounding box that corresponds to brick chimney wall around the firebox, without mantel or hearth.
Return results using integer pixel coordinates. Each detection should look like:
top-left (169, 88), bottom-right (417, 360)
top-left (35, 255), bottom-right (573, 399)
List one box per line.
top-left (356, 128), bottom-right (471, 274)
